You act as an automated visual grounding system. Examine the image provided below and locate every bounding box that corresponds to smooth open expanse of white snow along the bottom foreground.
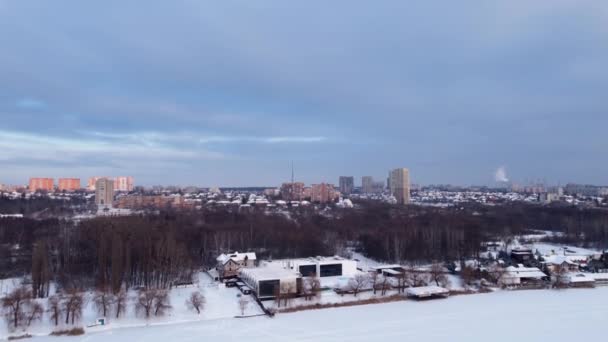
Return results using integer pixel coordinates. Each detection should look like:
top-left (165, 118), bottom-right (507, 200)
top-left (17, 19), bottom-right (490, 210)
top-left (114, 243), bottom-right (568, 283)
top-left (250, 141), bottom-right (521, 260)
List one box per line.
top-left (28, 287), bottom-right (608, 342)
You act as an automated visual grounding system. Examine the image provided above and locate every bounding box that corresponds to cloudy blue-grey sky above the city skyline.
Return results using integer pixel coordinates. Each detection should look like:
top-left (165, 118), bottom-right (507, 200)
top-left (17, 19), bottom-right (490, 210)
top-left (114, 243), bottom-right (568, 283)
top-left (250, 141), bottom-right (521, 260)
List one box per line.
top-left (0, 0), bottom-right (608, 186)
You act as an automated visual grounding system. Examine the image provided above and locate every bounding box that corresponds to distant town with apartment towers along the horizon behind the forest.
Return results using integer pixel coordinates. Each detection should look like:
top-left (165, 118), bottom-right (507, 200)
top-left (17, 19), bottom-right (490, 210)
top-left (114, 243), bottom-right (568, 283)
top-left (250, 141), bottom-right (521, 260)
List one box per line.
top-left (0, 168), bottom-right (608, 216)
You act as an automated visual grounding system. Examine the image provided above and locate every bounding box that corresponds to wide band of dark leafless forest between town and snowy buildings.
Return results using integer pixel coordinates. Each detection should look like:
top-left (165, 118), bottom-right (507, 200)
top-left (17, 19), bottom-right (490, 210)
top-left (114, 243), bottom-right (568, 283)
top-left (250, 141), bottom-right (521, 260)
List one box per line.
top-left (0, 202), bottom-right (608, 297)
